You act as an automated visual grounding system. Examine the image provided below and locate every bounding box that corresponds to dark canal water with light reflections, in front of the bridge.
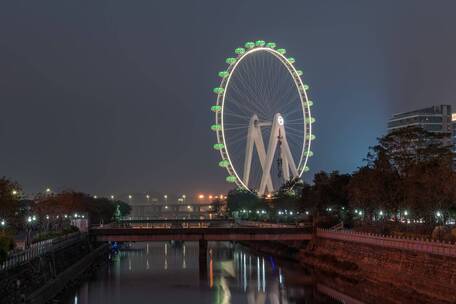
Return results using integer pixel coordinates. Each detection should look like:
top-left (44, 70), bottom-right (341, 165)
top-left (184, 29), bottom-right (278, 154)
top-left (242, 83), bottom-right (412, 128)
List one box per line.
top-left (63, 242), bottom-right (350, 304)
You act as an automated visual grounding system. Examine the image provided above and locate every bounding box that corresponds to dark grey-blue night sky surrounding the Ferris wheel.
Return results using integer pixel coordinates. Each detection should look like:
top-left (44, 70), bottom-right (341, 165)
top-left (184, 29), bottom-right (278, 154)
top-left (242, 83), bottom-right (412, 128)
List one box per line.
top-left (0, 0), bottom-right (456, 195)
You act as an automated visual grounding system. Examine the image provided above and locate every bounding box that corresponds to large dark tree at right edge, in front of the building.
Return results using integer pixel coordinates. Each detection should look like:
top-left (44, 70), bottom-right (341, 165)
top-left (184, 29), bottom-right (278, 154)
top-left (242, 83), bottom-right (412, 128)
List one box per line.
top-left (349, 127), bottom-right (456, 223)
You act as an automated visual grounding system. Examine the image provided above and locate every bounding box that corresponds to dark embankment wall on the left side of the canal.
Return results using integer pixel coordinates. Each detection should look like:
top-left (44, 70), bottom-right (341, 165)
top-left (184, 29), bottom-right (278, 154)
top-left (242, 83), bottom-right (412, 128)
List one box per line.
top-left (0, 237), bottom-right (107, 303)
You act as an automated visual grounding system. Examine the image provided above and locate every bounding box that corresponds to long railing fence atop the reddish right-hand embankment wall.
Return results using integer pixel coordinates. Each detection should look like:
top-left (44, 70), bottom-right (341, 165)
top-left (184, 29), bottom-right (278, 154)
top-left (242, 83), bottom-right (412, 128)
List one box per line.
top-left (317, 229), bottom-right (456, 257)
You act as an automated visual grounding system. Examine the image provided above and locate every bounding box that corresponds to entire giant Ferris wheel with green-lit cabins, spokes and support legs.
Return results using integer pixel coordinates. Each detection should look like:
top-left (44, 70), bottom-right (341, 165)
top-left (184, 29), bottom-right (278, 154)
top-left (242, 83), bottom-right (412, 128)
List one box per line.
top-left (211, 40), bottom-right (315, 195)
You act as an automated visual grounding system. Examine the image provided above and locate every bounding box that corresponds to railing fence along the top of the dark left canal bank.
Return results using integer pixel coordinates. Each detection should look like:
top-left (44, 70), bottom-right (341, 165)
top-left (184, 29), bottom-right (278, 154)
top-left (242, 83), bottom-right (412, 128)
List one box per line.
top-left (0, 232), bottom-right (85, 272)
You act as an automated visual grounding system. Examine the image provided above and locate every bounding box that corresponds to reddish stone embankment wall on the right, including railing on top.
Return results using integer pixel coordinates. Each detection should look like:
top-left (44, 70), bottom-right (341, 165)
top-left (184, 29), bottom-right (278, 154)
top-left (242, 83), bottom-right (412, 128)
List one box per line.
top-left (298, 230), bottom-right (456, 303)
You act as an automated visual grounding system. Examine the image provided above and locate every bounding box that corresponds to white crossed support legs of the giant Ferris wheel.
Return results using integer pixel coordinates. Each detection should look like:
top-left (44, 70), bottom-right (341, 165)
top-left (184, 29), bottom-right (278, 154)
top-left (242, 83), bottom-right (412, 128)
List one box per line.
top-left (243, 113), bottom-right (299, 196)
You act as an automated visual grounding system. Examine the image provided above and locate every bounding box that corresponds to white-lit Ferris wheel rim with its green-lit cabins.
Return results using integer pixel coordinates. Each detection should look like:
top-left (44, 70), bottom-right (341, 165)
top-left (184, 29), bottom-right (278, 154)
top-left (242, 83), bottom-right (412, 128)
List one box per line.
top-left (211, 40), bottom-right (315, 191)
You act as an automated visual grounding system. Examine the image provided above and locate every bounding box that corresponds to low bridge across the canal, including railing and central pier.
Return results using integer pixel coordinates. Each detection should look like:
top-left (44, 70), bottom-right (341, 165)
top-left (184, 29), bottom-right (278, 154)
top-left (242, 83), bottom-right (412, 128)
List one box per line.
top-left (90, 219), bottom-right (312, 276)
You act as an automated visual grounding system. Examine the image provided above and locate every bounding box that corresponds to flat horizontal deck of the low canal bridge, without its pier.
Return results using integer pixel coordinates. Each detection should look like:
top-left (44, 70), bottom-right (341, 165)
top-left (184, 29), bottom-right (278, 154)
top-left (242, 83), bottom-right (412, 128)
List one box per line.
top-left (90, 227), bottom-right (312, 242)
